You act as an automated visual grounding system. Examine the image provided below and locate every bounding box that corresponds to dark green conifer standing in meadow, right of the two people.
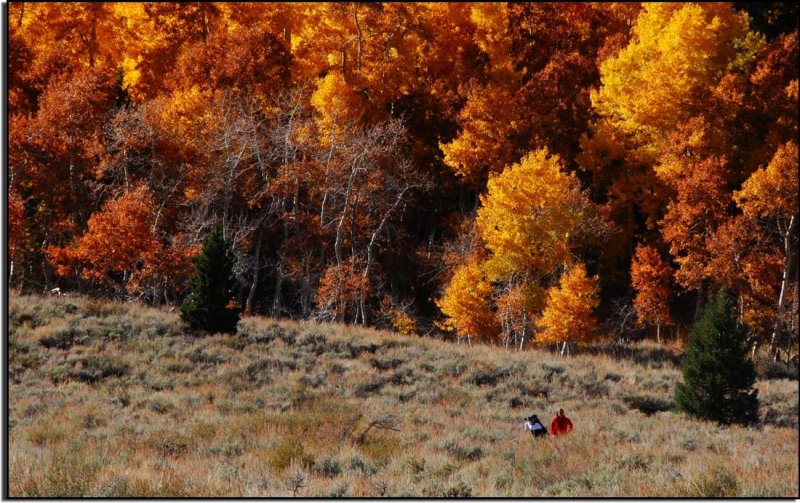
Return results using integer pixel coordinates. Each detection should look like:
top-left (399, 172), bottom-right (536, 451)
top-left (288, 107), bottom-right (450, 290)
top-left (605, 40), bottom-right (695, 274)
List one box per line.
top-left (675, 288), bottom-right (758, 424)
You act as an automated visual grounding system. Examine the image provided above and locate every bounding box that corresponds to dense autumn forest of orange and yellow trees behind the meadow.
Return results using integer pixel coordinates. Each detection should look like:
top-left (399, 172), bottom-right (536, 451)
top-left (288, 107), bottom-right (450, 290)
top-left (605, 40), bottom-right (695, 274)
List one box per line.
top-left (7, 2), bottom-right (798, 359)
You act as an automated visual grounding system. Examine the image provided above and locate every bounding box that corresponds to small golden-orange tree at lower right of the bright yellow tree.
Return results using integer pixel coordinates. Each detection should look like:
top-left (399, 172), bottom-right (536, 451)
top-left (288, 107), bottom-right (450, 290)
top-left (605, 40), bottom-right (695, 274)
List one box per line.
top-left (536, 263), bottom-right (600, 344)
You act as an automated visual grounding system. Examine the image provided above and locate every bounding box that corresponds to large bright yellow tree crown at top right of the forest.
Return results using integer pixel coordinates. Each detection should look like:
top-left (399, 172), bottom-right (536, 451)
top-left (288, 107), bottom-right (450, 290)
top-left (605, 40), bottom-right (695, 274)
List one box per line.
top-left (592, 3), bottom-right (757, 149)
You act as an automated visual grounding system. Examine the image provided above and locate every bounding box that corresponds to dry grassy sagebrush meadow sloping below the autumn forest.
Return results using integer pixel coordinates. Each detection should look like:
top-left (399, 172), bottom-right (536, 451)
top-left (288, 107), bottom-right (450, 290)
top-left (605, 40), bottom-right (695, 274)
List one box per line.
top-left (8, 292), bottom-right (799, 497)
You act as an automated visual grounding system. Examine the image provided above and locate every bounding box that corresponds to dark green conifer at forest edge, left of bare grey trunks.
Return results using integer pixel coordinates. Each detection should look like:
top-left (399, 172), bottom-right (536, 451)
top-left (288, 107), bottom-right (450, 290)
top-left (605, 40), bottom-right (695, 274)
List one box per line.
top-left (181, 225), bottom-right (239, 333)
